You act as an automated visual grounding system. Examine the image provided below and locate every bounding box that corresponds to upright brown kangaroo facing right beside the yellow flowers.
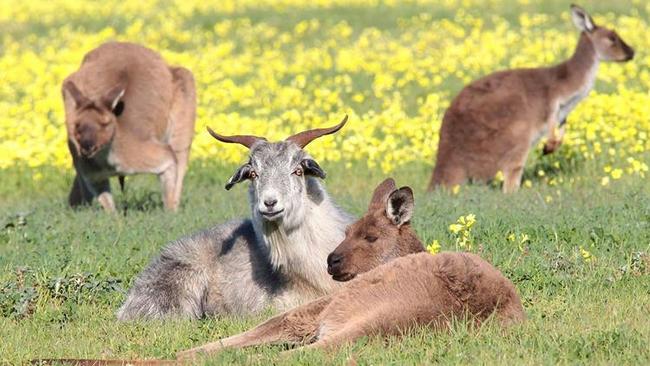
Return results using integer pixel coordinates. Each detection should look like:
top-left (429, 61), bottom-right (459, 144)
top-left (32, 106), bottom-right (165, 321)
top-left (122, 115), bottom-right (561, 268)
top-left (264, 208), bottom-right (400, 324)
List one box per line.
top-left (429, 5), bottom-right (634, 192)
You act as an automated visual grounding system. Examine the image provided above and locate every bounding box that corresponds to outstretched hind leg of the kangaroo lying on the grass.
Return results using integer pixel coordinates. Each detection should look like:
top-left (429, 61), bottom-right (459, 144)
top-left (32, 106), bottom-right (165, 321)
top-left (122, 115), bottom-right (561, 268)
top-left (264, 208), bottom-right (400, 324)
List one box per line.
top-left (176, 296), bottom-right (332, 360)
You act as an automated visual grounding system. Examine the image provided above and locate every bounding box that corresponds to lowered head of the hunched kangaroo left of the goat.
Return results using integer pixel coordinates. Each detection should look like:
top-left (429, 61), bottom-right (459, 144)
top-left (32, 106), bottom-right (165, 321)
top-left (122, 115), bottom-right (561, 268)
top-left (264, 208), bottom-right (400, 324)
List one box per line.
top-left (63, 75), bottom-right (126, 158)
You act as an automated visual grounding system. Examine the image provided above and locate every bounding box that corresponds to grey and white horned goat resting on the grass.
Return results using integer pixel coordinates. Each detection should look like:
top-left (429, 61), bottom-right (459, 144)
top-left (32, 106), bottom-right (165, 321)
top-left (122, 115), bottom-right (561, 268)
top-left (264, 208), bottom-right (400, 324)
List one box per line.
top-left (117, 116), bottom-right (351, 320)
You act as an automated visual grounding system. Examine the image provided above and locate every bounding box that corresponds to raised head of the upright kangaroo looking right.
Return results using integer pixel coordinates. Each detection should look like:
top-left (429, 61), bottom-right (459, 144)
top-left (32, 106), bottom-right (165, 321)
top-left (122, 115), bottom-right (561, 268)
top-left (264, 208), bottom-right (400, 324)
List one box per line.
top-left (571, 5), bottom-right (634, 62)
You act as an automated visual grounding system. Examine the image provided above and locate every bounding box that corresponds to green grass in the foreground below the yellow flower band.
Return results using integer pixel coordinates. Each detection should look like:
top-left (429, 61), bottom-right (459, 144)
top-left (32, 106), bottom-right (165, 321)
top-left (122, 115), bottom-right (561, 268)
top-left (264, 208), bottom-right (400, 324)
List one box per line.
top-left (0, 163), bottom-right (650, 364)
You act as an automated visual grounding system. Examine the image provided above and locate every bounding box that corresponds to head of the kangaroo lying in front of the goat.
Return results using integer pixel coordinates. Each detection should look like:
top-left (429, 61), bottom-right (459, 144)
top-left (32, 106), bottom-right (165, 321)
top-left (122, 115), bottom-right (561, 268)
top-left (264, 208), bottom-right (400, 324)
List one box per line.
top-left (327, 178), bottom-right (424, 281)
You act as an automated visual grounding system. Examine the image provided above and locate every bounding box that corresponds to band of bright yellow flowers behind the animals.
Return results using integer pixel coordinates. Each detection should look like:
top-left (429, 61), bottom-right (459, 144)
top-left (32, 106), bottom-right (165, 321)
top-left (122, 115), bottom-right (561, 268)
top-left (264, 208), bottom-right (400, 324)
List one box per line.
top-left (0, 0), bottom-right (650, 185)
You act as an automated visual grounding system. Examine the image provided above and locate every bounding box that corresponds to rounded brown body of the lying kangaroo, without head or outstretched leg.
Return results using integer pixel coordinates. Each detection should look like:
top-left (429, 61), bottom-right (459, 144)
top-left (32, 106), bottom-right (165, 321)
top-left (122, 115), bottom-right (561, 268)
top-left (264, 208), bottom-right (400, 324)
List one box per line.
top-left (323, 253), bottom-right (524, 333)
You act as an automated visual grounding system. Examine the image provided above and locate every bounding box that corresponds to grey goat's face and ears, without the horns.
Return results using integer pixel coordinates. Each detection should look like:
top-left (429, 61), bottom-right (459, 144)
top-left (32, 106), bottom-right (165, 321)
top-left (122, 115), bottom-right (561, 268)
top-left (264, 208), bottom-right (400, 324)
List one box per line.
top-left (231, 141), bottom-right (325, 226)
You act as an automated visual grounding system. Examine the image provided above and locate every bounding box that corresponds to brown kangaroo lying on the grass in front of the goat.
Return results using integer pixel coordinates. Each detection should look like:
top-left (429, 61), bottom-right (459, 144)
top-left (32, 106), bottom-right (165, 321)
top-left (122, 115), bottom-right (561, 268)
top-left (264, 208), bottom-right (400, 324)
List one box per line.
top-left (178, 179), bottom-right (525, 359)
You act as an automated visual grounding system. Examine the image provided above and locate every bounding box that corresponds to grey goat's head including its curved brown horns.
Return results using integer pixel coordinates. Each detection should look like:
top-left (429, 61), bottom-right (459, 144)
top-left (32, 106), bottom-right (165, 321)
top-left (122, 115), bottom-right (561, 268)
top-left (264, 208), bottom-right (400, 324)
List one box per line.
top-left (208, 116), bottom-right (347, 229)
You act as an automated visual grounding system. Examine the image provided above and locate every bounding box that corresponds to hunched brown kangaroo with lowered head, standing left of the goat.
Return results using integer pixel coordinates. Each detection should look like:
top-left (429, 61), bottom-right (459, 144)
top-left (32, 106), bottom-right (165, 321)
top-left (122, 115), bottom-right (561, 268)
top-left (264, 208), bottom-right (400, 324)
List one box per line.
top-left (62, 42), bottom-right (196, 211)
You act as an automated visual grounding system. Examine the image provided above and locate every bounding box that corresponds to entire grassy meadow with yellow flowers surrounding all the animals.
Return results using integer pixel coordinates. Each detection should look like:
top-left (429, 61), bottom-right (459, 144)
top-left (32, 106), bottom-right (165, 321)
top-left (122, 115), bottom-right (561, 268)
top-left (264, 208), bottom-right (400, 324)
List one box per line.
top-left (0, 0), bottom-right (650, 365)
